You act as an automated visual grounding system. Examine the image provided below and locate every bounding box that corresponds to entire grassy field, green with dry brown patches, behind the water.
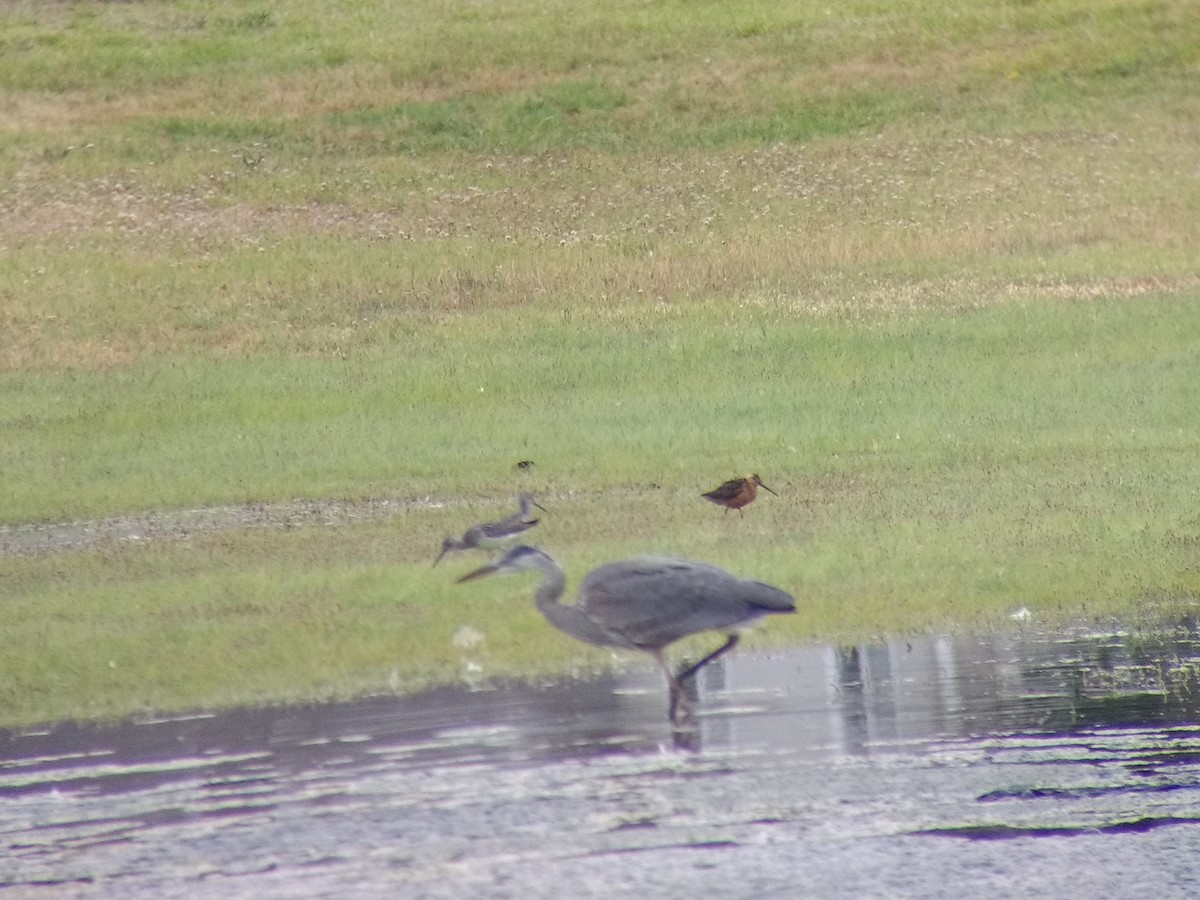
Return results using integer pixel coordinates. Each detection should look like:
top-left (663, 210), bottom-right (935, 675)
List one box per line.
top-left (0, 0), bottom-right (1200, 726)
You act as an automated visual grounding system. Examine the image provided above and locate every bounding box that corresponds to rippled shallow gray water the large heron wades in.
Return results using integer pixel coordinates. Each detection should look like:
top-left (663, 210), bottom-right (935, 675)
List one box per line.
top-left (0, 630), bottom-right (1200, 898)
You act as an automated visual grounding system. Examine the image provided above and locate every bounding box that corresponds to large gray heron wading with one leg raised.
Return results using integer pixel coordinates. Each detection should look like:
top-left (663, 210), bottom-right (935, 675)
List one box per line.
top-left (458, 546), bottom-right (796, 725)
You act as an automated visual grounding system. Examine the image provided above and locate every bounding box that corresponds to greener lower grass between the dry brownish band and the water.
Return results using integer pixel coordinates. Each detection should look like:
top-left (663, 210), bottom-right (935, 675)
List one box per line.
top-left (0, 292), bottom-right (1200, 720)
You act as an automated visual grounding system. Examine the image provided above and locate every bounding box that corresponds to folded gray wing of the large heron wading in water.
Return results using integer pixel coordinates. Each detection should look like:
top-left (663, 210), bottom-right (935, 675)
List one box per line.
top-left (578, 557), bottom-right (796, 647)
